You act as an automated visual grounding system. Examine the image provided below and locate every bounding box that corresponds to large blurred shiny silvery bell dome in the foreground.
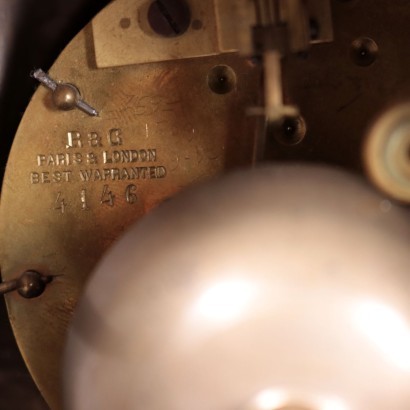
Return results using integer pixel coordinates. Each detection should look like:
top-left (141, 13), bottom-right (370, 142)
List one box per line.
top-left (65, 166), bottom-right (410, 410)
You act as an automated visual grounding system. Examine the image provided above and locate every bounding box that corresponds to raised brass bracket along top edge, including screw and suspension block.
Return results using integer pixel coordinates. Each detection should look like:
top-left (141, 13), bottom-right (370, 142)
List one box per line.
top-left (93, 0), bottom-right (333, 67)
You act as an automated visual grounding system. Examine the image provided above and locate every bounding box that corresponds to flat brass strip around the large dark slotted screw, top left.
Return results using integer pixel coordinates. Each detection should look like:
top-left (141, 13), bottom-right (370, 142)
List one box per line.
top-left (93, 0), bottom-right (229, 67)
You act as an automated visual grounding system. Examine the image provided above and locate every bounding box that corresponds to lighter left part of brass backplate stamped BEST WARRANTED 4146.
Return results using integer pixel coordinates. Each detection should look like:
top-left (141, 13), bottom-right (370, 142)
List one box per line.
top-left (0, 1), bottom-right (260, 409)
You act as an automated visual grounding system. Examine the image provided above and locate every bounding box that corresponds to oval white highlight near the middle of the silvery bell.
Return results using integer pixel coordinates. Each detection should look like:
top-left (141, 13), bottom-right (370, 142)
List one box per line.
top-left (195, 280), bottom-right (256, 322)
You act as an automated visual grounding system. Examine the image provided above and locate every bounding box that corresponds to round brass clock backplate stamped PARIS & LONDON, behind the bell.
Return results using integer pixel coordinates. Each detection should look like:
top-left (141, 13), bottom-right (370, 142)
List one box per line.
top-left (0, 0), bottom-right (410, 409)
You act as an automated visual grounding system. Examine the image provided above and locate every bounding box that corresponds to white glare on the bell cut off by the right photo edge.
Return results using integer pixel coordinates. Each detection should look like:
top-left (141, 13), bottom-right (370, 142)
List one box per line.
top-left (354, 301), bottom-right (410, 371)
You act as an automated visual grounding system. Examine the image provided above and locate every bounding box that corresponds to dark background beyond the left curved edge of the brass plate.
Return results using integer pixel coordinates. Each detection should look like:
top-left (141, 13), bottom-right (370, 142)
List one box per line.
top-left (0, 0), bottom-right (109, 410)
